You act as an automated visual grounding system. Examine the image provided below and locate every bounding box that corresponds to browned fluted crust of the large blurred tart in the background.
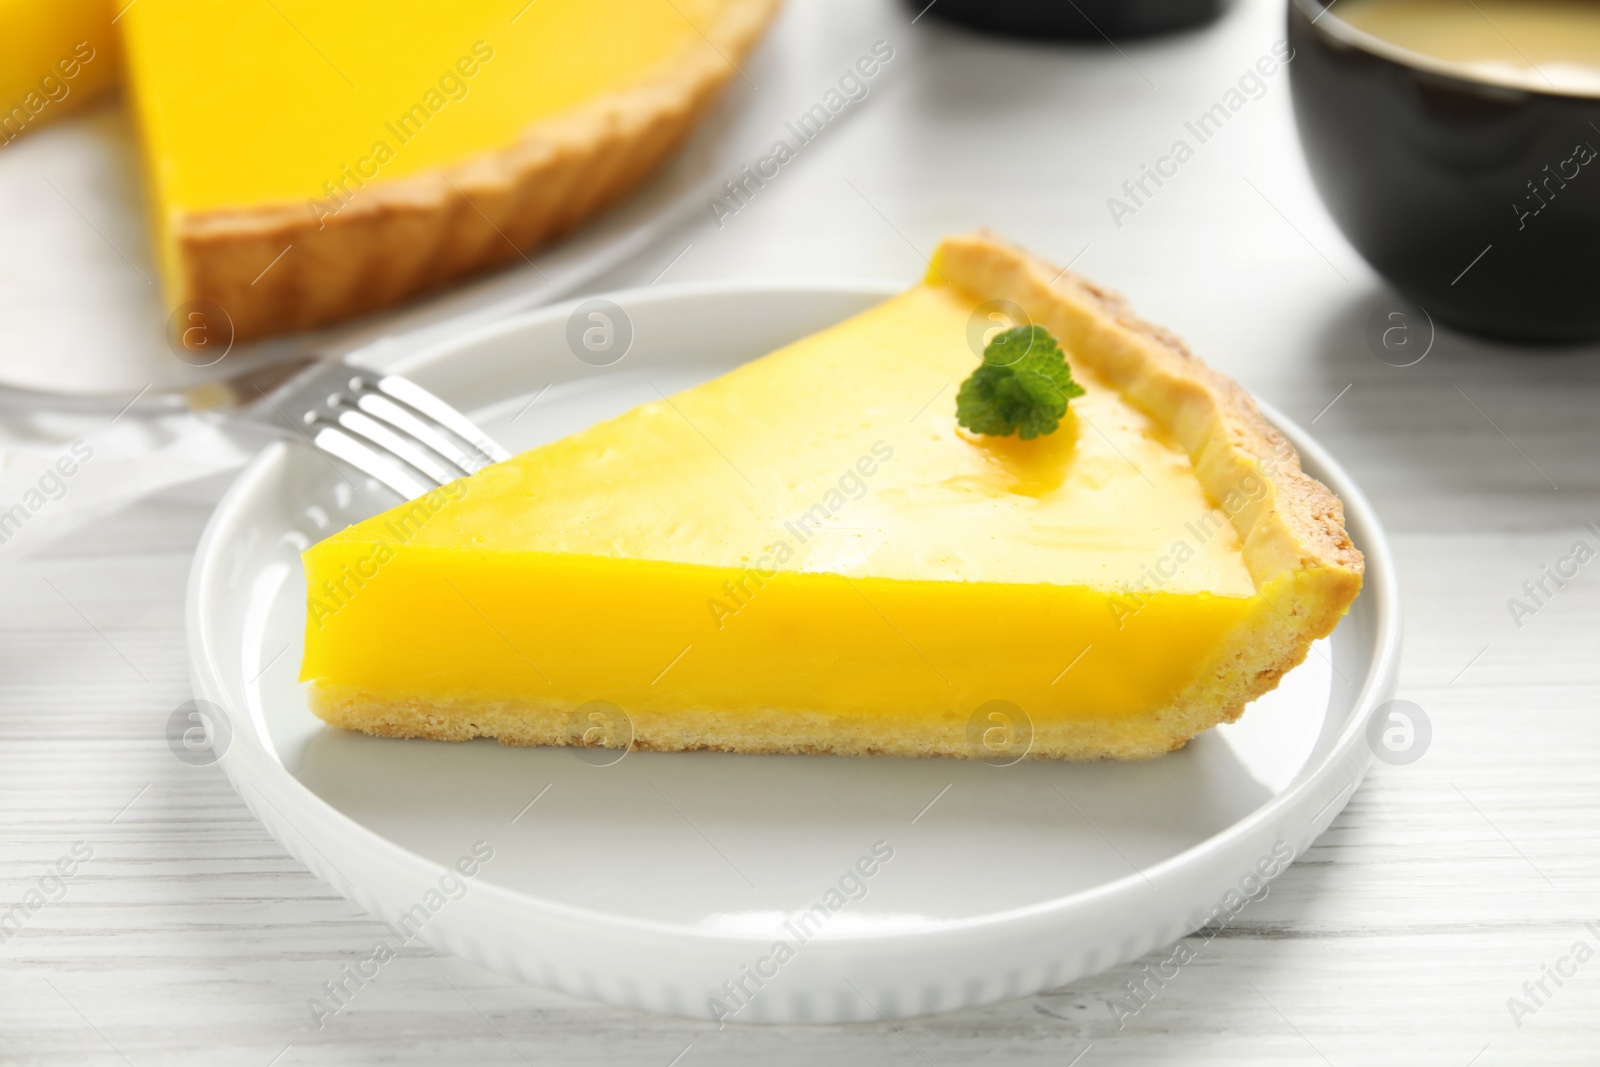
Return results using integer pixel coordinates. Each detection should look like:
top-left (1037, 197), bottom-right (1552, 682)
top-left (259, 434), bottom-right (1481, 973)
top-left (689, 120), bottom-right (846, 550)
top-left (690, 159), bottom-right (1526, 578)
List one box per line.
top-left (166, 0), bottom-right (778, 341)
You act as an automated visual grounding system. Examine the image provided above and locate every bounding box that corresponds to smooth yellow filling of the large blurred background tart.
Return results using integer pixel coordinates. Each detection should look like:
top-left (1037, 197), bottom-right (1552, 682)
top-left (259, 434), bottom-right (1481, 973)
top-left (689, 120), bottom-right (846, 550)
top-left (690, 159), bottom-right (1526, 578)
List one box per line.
top-left (120, 0), bottom-right (723, 211)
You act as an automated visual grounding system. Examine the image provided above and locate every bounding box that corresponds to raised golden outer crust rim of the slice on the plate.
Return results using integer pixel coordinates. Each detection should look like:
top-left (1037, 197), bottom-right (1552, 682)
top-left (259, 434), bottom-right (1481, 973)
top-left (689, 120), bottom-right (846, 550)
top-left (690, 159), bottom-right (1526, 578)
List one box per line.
top-left (930, 230), bottom-right (1365, 747)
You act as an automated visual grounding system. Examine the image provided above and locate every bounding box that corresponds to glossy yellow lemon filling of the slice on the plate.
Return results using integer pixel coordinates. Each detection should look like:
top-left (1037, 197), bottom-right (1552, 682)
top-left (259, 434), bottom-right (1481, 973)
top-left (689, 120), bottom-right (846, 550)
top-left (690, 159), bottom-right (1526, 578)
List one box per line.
top-left (302, 283), bottom-right (1266, 721)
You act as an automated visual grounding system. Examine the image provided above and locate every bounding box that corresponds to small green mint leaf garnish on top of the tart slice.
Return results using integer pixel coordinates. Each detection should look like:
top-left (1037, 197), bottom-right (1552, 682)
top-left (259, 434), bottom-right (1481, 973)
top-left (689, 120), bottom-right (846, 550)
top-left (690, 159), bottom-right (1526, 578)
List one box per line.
top-left (955, 325), bottom-right (1083, 440)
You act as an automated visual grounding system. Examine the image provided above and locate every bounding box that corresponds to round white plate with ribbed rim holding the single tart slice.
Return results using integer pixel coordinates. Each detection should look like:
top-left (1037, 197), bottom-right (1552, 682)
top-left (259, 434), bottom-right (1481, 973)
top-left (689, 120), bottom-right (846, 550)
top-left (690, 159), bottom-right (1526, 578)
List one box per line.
top-left (189, 285), bottom-right (1400, 1022)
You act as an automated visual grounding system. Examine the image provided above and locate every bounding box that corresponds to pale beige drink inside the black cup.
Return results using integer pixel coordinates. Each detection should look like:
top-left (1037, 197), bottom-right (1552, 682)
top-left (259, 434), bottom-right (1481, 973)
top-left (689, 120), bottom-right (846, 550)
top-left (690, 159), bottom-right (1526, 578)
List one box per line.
top-left (1330, 0), bottom-right (1600, 96)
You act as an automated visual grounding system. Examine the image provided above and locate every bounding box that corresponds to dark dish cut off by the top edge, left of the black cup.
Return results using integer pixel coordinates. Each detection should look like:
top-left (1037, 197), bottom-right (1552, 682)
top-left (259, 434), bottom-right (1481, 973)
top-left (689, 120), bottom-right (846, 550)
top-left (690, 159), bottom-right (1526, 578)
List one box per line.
top-left (907, 0), bottom-right (1232, 40)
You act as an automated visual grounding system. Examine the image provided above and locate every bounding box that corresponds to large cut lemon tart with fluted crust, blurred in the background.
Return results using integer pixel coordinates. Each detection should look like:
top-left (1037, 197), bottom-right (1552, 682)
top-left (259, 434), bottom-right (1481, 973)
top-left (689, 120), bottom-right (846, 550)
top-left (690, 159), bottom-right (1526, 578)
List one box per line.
top-left (116, 0), bottom-right (776, 339)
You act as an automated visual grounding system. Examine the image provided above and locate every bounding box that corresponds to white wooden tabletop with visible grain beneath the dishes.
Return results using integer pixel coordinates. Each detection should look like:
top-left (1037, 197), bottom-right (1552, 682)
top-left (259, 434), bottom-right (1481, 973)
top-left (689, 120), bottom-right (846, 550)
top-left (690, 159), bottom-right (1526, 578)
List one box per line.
top-left (0, 0), bottom-right (1600, 1067)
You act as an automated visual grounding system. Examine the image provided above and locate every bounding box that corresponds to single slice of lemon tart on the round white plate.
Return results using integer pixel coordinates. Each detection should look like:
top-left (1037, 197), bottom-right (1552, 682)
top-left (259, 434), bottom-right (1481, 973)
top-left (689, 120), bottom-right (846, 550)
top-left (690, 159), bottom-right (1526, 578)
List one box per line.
top-left (301, 234), bottom-right (1362, 758)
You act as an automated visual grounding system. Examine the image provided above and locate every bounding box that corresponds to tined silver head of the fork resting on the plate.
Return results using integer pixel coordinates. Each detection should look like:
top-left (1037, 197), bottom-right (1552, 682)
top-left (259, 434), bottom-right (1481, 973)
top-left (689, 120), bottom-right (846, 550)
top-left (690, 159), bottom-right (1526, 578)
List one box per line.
top-left (240, 362), bottom-right (510, 501)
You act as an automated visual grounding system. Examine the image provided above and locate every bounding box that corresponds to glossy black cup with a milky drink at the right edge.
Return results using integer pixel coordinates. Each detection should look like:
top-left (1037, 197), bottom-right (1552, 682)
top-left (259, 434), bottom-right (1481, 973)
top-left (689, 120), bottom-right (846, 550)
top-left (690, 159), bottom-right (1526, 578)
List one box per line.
top-left (1288, 0), bottom-right (1600, 344)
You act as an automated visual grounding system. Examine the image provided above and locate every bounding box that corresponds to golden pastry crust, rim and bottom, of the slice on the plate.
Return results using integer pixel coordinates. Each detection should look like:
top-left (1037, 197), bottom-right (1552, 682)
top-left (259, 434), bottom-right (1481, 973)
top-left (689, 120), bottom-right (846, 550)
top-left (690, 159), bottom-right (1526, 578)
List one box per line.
top-left (310, 234), bottom-right (1363, 760)
